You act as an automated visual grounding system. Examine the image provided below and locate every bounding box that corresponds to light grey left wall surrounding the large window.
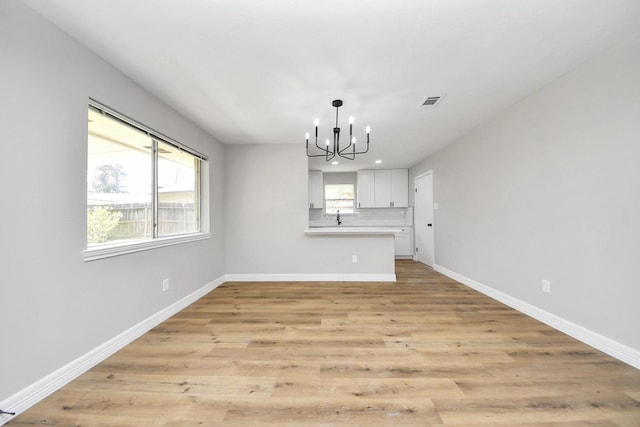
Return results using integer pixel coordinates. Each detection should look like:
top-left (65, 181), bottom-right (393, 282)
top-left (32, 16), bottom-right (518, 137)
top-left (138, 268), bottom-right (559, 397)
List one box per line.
top-left (0, 1), bottom-right (225, 402)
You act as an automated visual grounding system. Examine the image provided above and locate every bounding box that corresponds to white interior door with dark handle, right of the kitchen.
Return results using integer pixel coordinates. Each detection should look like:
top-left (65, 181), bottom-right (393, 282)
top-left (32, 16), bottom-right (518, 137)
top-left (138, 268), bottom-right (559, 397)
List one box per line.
top-left (413, 172), bottom-right (435, 267)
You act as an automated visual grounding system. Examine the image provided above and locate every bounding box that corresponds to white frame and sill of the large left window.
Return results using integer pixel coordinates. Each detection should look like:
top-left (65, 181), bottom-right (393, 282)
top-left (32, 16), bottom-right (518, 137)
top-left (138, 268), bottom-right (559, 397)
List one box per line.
top-left (83, 98), bottom-right (211, 261)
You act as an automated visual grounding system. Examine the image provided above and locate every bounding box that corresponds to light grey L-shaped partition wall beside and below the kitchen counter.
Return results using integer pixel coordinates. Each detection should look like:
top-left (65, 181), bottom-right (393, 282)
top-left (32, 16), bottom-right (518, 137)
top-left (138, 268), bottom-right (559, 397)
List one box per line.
top-left (225, 144), bottom-right (395, 278)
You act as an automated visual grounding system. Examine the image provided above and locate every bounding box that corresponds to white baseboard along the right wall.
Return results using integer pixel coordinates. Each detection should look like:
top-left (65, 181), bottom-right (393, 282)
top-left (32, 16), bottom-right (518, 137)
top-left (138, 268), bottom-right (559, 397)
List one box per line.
top-left (434, 265), bottom-right (640, 369)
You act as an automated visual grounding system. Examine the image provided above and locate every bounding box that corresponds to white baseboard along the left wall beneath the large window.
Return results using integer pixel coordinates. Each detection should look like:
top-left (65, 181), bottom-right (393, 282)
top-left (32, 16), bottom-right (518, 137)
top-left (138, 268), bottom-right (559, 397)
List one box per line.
top-left (0, 276), bottom-right (224, 425)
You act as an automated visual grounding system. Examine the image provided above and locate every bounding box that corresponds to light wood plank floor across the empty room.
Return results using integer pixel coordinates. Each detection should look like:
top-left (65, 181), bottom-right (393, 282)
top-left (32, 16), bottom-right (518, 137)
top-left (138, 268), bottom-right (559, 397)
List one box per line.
top-left (9, 261), bottom-right (640, 426)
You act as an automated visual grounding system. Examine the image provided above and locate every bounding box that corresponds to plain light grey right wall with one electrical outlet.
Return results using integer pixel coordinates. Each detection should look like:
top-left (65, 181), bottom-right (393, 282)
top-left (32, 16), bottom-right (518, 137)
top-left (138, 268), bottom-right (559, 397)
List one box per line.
top-left (410, 37), bottom-right (640, 354)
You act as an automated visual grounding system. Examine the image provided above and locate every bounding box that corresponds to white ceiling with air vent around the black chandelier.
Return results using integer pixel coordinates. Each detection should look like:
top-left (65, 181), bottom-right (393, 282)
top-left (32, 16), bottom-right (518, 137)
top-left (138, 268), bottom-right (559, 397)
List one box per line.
top-left (25, 0), bottom-right (640, 171)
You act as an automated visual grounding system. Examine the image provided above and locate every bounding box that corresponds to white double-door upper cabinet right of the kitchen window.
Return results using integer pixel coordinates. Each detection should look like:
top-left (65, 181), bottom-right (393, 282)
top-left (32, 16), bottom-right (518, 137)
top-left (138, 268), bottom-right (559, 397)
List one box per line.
top-left (358, 169), bottom-right (409, 208)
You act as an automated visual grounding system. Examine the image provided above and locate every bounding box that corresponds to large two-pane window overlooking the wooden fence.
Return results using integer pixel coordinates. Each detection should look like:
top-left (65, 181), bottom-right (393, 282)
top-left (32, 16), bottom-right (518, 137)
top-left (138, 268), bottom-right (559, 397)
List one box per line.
top-left (85, 101), bottom-right (206, 259)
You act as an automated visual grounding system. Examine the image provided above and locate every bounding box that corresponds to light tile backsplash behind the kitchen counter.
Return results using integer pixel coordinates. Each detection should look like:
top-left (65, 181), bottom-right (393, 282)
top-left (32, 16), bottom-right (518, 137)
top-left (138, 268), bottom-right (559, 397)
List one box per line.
top-left (309, 207), bottom-right (413, 227)
